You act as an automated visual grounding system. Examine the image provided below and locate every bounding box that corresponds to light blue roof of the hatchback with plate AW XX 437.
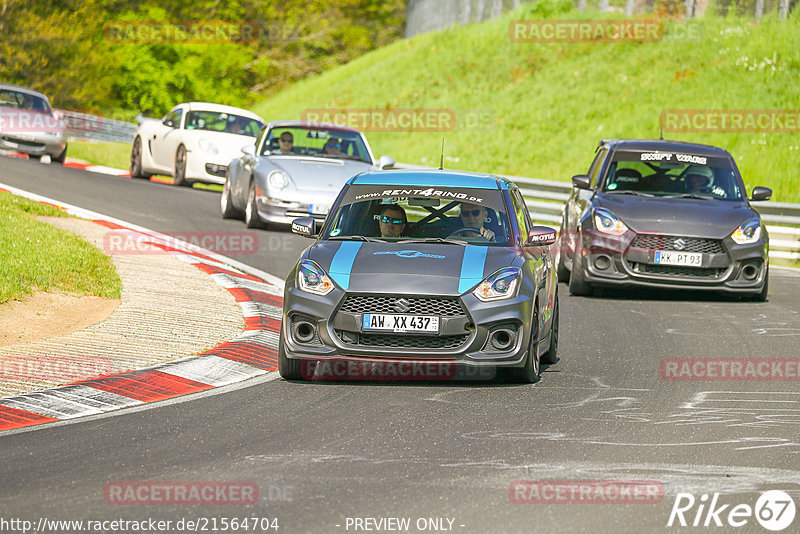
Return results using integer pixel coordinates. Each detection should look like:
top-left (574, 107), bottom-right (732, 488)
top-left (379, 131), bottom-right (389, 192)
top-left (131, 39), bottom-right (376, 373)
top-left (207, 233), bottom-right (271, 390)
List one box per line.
top-left (348, 169), bottom-right (514, 189)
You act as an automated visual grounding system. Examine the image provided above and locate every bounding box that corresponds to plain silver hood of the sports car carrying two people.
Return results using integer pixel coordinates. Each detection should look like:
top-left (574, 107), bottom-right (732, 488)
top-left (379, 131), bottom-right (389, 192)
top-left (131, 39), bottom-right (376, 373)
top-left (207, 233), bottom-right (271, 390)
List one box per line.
top-left (259, 156), bottom-right (374, 193)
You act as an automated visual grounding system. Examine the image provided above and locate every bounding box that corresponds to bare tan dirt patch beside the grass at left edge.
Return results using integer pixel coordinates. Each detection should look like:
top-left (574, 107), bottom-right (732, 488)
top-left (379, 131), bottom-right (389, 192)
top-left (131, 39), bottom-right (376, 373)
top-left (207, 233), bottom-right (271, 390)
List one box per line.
top-left (0, 292), bottom-right (120, 346)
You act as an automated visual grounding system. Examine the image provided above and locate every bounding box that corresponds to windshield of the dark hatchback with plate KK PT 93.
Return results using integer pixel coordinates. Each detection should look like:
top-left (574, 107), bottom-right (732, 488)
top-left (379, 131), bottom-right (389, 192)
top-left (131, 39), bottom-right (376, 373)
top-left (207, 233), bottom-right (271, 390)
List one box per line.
top-left (602, 152), bottom-right (742, 200)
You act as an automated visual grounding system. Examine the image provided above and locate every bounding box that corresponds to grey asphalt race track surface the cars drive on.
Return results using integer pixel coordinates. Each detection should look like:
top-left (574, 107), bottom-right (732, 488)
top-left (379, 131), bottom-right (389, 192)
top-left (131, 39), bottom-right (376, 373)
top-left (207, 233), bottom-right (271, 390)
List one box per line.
top-left (0, 157), bottom-right (800, 533)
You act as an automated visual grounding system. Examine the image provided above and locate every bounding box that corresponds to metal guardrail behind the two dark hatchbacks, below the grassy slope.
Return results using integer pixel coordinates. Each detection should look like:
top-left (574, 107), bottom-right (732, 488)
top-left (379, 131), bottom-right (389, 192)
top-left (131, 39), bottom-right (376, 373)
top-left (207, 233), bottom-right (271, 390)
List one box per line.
top-left (395, 163), bottom-right (800, 260)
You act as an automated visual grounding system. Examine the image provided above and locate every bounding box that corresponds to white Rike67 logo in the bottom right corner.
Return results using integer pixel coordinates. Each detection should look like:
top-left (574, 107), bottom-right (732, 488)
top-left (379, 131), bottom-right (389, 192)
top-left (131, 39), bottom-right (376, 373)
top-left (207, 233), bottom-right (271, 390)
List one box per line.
top-left (667, 490), bottom-right (796, 532)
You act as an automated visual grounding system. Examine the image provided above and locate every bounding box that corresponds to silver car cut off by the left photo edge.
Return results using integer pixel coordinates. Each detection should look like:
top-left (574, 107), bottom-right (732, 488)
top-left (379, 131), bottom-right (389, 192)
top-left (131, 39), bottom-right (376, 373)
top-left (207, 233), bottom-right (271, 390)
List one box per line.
top-left (0, 84), bottom-right (67, 163)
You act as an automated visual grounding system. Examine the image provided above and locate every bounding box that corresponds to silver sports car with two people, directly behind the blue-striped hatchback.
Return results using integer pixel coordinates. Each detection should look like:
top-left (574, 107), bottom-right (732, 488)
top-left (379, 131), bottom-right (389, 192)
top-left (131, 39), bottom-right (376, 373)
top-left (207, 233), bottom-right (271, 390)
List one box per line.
top-left (221, 121), bottom-right (394, 228)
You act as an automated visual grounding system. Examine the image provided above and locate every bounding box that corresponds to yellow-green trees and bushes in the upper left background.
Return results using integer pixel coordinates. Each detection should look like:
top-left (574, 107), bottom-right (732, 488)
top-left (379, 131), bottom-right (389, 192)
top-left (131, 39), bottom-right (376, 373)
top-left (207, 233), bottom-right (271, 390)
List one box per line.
top-left (0, 0), bottom-right (405, 120)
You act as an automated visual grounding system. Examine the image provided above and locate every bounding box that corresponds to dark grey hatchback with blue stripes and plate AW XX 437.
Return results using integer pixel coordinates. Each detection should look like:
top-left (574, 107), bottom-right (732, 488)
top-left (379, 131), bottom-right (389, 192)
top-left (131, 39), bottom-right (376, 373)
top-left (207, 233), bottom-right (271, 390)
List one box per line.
top-left (279, 171), bottom-right (559, 382)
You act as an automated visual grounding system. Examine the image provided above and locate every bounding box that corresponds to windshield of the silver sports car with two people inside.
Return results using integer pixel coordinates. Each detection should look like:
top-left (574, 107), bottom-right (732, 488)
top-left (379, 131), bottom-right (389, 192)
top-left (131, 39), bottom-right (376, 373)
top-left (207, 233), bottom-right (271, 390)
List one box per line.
top-left (261, 126), bottom-right (372, 163)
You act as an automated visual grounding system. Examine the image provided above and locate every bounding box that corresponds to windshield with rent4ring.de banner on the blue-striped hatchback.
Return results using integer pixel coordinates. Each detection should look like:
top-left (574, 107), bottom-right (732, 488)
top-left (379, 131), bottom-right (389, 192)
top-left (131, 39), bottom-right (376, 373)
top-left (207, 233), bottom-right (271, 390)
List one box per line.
top-left (322, 185), bottom-right (511, 246)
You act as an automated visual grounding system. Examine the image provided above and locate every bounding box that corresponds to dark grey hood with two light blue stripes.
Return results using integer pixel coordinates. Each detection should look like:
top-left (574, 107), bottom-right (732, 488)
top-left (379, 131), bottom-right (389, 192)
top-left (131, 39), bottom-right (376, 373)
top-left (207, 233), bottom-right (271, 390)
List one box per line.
top-left (305, 241), bottom-right (522, 295)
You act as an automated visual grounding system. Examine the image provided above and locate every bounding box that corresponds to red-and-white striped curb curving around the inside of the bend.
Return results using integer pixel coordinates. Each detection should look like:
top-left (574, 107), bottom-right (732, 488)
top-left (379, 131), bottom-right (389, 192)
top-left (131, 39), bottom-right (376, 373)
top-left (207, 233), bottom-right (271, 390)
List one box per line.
top-left (0, 184), bottom-right (283, 431)
